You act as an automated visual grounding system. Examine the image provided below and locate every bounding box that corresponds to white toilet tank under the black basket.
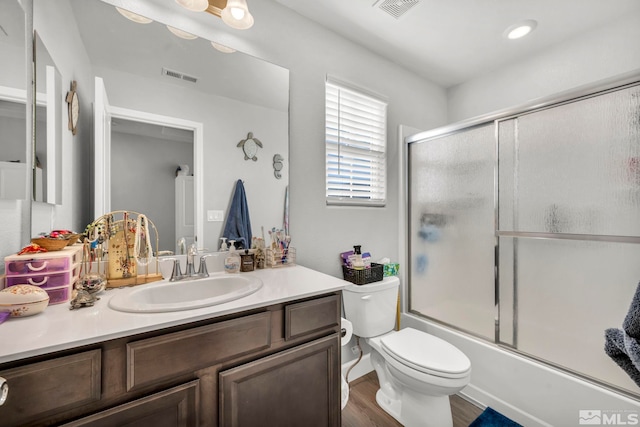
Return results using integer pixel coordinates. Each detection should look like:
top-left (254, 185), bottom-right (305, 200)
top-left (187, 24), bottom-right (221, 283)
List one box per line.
top-left (342, 276), bottom-right (400, 338)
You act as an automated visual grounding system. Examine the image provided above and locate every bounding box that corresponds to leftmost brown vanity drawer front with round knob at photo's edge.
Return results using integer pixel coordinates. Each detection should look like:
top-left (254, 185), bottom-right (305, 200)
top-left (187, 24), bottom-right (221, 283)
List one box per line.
top-left (0, 350), bottom-right (102, 425)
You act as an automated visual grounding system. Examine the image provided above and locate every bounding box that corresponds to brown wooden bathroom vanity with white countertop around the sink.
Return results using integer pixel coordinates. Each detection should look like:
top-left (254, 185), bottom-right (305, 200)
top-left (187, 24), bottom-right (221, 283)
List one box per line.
top-left (0, 266), bottom-right (346, 426)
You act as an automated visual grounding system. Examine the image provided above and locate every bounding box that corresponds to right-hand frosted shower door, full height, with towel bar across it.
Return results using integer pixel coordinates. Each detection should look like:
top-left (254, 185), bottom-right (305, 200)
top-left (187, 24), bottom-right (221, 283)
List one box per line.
top-left (497, 86), bottom-right (640, 392)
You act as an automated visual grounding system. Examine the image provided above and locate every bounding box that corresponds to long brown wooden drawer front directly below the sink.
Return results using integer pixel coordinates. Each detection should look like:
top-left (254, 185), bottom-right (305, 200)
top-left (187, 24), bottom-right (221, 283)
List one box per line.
top-left (127, 312), bottom-right (271, 390)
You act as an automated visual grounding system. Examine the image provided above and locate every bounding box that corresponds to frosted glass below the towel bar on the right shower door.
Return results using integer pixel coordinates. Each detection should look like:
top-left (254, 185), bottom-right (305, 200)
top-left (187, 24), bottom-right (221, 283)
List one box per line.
top-left (516, 238), bottom-right (640, 393)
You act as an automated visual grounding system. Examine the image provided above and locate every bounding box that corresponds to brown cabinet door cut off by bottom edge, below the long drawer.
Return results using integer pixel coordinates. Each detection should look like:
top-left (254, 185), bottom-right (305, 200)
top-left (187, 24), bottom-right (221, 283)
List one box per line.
top-left (65, 380), bottom-right (199, 427)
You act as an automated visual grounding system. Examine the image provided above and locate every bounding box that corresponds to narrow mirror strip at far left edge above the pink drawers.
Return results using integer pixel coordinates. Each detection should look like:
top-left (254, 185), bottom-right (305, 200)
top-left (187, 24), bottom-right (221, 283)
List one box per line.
top-left (0, 1), bottom-right (28, 200)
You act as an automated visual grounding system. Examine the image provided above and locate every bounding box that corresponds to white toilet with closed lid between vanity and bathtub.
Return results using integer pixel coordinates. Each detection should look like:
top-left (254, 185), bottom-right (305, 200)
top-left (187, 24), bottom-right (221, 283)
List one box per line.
top-left (342, 276), bottom-right (471, 427)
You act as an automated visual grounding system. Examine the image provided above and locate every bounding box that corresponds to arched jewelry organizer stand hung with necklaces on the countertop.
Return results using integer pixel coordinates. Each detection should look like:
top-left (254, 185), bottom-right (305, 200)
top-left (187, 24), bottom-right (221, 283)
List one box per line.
top-left (86, 211), bottom-right (162, 288)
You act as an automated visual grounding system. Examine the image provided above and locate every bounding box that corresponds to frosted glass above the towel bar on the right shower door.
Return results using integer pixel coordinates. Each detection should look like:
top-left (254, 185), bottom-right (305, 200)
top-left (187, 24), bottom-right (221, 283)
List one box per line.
top-left (512, 86), bottom-right (640, 236)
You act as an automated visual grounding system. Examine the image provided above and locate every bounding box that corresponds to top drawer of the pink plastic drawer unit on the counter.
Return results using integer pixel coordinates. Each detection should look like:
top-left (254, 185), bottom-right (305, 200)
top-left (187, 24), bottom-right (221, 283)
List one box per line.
top-left (4, 245), bottom-right (82, 277)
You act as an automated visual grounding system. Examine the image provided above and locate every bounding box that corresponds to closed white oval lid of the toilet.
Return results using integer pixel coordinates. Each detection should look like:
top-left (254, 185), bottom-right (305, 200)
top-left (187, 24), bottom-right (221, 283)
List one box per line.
top-left (381, 328), bottom-right (471, 378)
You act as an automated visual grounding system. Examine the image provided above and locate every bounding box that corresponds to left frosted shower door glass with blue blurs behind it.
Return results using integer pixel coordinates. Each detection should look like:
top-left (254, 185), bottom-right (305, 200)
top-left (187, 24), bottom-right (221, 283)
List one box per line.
top-left (409, 125), bottom-right (495, 340)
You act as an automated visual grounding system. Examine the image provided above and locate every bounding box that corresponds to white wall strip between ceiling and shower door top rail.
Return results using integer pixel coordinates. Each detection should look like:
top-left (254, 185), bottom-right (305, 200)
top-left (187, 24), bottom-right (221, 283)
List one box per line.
top-left (448, 15), bottom-right (640, 122)
